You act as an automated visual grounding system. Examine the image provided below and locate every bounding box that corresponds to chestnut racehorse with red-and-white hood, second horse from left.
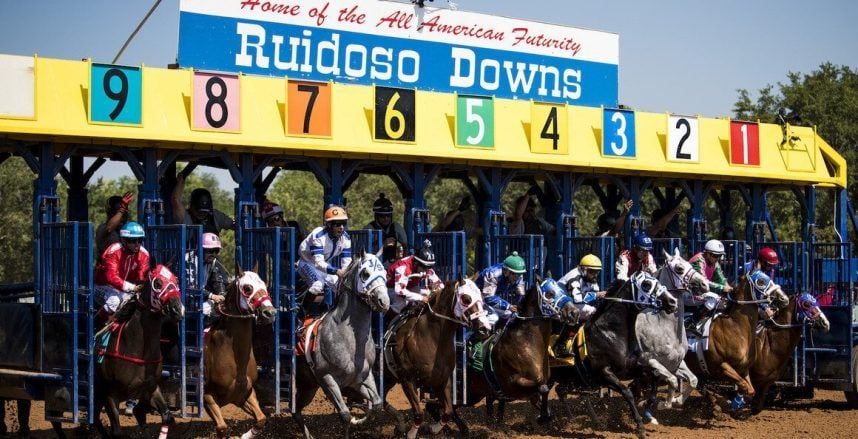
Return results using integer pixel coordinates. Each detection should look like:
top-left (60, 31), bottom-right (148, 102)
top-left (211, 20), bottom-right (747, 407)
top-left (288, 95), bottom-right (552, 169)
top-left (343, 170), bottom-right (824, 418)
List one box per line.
top-left (203, 267), bottom-right (276, 439)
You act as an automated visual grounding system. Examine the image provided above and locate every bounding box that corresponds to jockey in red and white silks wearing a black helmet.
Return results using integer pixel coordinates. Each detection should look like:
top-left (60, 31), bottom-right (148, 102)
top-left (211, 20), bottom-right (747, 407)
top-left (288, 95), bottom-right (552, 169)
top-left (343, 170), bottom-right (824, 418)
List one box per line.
top-left (387, 240), bottom-right (444, 314)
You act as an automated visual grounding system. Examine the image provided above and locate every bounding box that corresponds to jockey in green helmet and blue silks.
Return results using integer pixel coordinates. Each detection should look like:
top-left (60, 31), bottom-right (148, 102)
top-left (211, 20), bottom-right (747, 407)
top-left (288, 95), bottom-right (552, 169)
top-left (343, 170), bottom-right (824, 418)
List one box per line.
top-left (475, 252), bottom-right (527, 326)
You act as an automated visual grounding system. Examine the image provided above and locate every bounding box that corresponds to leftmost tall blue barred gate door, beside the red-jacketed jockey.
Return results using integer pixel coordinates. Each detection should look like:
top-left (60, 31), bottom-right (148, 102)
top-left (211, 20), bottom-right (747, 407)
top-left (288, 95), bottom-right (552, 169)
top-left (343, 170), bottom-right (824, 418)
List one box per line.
top-left (38, 222), bottom-right (93, 423)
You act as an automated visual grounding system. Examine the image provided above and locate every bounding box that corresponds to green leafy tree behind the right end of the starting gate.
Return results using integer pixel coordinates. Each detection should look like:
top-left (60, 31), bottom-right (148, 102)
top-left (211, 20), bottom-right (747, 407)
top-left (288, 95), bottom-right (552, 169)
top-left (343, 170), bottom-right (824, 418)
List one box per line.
top-left (733, 63), bottom-right (858, 241)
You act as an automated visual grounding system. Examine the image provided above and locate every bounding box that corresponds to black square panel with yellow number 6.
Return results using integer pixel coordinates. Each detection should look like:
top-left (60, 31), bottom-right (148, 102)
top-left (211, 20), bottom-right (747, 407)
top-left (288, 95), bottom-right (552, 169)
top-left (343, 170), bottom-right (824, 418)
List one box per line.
top-left (373, 87), bottom-right (417, 143)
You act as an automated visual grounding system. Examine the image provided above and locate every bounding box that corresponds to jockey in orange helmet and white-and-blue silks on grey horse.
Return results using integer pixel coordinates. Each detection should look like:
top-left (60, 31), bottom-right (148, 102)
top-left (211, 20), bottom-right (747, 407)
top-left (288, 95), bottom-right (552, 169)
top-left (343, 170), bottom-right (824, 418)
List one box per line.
top-left (297, 206), bottom-right (352, 312)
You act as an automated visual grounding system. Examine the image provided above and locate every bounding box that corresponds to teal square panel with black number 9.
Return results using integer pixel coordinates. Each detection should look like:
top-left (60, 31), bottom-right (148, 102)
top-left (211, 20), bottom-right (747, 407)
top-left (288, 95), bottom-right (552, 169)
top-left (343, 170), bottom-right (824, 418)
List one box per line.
top-left (89, 63), bottom-right (143, 126)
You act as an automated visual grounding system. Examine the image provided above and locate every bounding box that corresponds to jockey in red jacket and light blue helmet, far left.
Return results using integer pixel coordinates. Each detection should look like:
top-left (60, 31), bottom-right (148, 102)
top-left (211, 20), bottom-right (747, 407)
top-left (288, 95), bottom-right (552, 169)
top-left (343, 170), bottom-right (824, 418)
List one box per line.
top-left (95, 221), bottom-right (149, 321)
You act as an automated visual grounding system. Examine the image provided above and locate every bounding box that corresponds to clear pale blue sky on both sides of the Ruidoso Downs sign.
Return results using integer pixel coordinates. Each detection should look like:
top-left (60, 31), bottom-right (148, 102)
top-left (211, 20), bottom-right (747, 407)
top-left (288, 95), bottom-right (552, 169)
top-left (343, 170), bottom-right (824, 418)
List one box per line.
top-left (0, 0), bottom-right (858, 184)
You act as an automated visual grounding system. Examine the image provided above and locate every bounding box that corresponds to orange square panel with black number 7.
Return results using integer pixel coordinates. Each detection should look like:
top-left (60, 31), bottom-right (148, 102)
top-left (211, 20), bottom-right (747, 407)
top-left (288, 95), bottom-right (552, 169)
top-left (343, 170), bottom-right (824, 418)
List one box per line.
top-left (286, 79), bottom-right (333, 138)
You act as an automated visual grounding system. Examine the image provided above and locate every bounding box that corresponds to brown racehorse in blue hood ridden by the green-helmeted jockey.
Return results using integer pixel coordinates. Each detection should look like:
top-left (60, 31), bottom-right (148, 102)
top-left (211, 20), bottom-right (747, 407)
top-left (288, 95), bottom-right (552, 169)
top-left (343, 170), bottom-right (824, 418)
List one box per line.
top-left (467, 275), bottom-right (578, 423)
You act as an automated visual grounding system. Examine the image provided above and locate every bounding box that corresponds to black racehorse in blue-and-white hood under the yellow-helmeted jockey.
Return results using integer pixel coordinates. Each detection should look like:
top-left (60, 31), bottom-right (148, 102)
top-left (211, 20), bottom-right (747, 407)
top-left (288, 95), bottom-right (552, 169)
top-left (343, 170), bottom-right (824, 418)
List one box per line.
top-left (552, 271), bottom-right (678, 437)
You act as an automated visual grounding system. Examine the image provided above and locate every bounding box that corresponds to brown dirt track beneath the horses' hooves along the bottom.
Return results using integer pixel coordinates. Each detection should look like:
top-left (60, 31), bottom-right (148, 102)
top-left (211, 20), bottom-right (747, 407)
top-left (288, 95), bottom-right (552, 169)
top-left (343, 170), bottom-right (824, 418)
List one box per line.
top-left (6, 388), bottom-right (858, 439)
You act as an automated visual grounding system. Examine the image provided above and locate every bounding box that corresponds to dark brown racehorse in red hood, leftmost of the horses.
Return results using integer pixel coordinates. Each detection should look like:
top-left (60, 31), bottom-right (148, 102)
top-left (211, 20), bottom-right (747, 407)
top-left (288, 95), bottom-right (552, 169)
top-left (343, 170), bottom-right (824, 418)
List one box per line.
top-left (93, 265), bottom-right (185, 437)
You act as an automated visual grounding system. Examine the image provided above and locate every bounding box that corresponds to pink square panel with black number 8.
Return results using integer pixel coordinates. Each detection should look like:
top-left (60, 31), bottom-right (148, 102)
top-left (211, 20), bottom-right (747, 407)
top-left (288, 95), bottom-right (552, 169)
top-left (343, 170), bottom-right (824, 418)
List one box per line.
top-left (191, 72), bottom-right (241, 133)
